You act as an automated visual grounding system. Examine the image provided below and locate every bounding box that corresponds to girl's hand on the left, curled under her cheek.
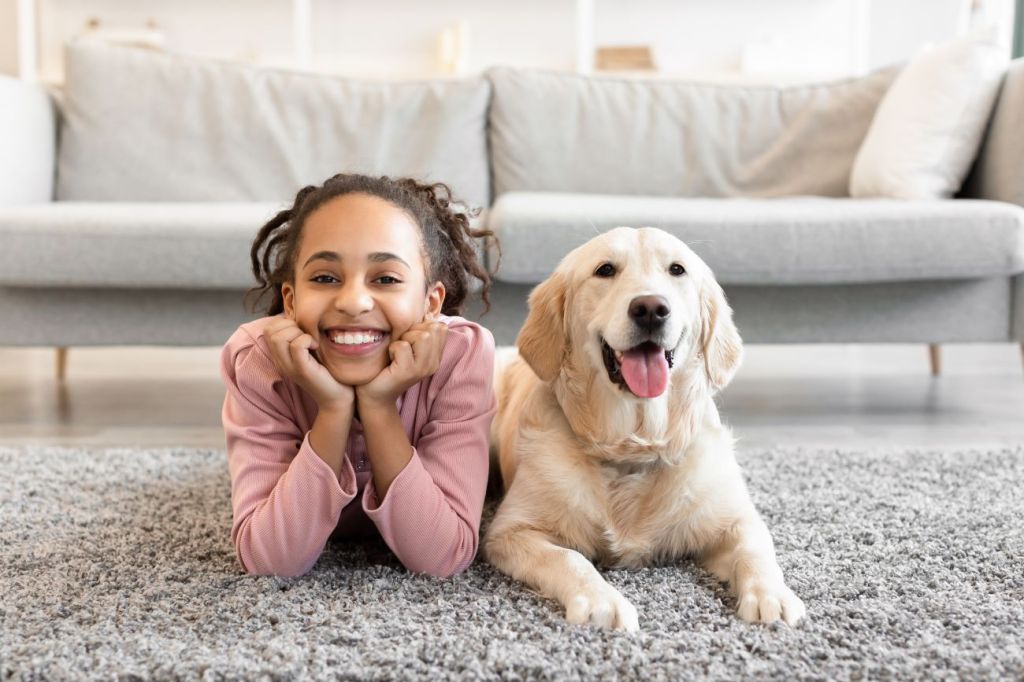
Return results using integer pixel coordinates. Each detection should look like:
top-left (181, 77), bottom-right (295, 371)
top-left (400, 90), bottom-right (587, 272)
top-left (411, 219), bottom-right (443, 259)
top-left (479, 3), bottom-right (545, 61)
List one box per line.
top-left (263, 317), bottom-right (355, 410)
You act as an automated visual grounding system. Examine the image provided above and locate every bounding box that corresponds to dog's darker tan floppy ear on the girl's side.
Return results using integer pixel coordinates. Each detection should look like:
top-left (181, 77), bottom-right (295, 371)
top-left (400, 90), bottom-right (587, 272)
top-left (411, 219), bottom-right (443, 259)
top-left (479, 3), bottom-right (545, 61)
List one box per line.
top-left (515, 272), bottom-right (568, 381)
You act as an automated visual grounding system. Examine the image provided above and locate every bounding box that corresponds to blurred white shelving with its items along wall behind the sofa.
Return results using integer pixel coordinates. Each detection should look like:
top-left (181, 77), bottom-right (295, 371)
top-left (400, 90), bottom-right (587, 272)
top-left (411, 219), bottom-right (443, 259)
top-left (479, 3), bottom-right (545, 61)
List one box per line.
top-left (0, 0), bottom-right (1024, 83)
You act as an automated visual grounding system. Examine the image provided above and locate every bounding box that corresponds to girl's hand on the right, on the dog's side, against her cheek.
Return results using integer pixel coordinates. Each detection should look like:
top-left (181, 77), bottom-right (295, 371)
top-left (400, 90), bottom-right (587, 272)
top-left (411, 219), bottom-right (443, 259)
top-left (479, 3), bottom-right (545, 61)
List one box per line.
top-left (355, 318), bottom-right (447, 409)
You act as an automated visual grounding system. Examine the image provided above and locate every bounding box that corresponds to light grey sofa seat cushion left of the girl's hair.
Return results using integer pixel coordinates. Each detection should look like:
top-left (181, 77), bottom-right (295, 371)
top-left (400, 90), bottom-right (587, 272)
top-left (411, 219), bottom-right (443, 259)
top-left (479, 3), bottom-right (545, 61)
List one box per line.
top-left (0, 202), bottom-right (276, 290)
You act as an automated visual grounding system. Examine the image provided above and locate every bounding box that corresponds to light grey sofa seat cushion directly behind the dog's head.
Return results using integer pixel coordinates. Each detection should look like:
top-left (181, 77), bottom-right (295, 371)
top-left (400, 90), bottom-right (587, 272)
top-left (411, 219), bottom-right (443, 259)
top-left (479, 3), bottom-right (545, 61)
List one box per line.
top-left (488, 193), bottom-right (1024, 285)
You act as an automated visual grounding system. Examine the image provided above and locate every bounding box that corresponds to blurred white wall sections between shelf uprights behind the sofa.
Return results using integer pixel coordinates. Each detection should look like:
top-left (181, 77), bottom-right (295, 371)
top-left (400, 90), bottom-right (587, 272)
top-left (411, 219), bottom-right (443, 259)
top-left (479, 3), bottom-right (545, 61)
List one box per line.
top-left (0, 0), bottom-right (1013, 80)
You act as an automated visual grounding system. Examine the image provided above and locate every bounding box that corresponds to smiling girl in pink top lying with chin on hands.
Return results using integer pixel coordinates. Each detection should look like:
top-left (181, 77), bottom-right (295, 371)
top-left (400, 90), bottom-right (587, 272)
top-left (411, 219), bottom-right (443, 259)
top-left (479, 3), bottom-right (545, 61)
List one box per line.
top-left (221, 175), bottom-right (495, 577)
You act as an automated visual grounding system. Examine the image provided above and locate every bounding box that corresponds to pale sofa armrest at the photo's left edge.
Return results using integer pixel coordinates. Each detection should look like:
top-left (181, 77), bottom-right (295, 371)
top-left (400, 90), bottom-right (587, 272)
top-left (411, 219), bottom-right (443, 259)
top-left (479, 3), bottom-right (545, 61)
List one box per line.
top-left (0, 76), bottom-right (57, 206)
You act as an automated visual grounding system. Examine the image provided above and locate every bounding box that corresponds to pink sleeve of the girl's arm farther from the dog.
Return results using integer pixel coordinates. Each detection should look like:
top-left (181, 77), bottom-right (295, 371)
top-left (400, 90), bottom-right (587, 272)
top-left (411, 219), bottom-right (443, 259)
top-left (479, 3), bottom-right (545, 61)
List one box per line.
top-left (220, 330), bottom-right (356, 576)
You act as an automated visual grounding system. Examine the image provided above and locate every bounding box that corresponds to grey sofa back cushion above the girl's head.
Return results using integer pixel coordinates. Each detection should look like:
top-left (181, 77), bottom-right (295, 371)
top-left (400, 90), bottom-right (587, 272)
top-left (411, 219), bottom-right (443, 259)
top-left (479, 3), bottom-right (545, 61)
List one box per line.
top-left (56, 43), bottom-right (490, 206)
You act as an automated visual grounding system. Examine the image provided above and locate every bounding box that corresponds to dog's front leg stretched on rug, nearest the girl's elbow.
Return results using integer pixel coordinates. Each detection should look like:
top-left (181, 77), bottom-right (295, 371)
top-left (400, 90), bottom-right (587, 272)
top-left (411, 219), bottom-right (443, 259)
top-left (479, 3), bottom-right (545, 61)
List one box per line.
top-left (484, 528), bottom-right (639, 632)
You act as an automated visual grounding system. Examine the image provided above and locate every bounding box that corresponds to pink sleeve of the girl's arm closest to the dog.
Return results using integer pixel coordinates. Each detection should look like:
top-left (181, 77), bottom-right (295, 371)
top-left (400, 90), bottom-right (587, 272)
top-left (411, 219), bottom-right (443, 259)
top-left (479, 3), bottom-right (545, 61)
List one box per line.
top-left (362, 325), bottom-right (496, 578)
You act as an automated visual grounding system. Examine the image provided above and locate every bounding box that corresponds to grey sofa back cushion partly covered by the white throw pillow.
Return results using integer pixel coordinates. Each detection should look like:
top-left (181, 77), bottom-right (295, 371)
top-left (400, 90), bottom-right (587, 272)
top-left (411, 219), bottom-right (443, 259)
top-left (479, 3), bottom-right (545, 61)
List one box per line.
top-left (487, 67), bottom-right (898, 197)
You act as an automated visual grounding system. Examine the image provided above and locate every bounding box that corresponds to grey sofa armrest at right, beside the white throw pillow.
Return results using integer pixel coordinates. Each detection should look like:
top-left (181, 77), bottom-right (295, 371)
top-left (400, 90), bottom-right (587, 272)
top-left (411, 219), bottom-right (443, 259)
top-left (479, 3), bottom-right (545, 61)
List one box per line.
top-left (962, 58), bottom-right (1024, 206)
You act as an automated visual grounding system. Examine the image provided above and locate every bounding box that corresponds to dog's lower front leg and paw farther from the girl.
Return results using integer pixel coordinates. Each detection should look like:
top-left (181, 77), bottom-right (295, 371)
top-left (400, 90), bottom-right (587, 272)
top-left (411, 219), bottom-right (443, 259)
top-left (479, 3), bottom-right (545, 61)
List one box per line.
top-left (702, 509), bottom-right (807, 626)
